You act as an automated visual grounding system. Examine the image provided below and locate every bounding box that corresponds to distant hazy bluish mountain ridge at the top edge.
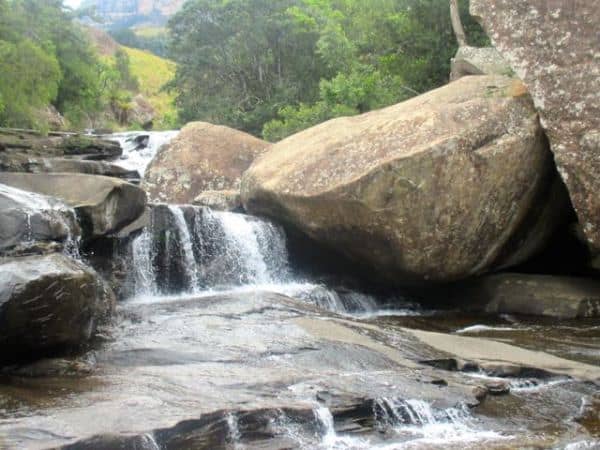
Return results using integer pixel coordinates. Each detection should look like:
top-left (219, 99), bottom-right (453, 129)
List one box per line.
top-left (82, 0), bottom-right (185, 25)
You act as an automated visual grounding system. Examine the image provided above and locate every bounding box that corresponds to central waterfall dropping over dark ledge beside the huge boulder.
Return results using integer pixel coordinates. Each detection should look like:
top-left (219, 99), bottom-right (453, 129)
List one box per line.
top-left (130, 204), bottom-right (288, 296)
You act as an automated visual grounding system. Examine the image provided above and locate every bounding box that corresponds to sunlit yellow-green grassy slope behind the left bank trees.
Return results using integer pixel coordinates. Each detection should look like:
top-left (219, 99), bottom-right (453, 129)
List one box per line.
top-left (122, 47), bottom-right (177, 129)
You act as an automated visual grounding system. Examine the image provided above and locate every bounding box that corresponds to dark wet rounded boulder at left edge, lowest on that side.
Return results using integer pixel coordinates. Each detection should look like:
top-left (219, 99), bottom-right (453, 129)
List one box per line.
top-left (0, 253), bottom-right (115, 363)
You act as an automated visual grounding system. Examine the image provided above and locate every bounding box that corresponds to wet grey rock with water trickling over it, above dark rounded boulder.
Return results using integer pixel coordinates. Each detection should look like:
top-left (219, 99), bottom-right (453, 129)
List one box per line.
top-left (0, 184), bottom-right (80, 255)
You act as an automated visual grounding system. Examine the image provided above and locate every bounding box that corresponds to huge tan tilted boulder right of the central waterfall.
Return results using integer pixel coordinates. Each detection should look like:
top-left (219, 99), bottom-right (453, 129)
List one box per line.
top-left (242, 76), bottom-right (565, 283)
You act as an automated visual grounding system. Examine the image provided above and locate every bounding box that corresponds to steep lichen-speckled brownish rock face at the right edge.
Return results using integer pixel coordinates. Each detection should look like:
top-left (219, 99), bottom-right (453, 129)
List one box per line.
top-left (471, 0), bottom-right (600, 252)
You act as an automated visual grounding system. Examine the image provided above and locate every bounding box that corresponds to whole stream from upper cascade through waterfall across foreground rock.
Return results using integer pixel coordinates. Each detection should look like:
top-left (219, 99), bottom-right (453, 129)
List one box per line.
top-left (0, 133), bottom-right (600, 450)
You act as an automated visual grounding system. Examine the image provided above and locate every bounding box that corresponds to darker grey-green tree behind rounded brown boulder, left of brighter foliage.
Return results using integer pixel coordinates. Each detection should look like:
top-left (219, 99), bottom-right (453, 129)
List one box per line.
top-left (169, 0), bottom-right (329, 134)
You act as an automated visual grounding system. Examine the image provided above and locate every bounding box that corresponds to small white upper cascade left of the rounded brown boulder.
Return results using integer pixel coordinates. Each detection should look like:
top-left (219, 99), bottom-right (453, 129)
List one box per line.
top-left (109, 131), bottom-right (179, 177)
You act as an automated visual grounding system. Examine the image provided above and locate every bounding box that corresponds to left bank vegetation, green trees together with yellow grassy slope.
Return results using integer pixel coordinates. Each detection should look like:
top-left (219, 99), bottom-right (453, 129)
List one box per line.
top-left (0, 0), bottom-right (176, 130)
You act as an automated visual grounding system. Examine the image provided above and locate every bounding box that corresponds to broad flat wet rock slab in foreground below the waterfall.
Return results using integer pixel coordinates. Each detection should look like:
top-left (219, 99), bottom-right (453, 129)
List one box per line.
top-left (0, 291), bottom-right (600, 449)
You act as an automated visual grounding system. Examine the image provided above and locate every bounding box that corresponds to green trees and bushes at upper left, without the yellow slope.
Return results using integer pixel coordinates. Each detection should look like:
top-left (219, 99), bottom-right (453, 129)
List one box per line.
top-left (0, 0), bottom-right (136, 128)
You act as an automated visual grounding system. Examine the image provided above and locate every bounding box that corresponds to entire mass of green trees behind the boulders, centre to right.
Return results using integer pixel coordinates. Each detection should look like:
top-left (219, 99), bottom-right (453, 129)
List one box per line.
top-left (169, 0), bottom-right (486, 140)
